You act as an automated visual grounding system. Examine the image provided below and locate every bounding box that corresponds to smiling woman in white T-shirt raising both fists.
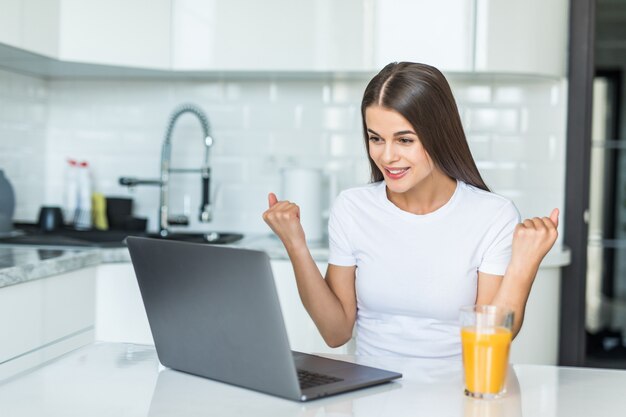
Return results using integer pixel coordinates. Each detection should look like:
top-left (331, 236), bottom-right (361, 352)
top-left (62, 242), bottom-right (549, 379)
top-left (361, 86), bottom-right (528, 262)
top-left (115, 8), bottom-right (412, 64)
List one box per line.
top-left (263, 62), bottom-right (558, 357)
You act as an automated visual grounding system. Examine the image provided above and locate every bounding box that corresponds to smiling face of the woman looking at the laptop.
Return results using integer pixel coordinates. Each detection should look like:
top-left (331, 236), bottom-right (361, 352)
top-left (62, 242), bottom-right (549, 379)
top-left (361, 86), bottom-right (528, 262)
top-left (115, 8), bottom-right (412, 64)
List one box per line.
top-left (365, 106), bottom-right (436, 193)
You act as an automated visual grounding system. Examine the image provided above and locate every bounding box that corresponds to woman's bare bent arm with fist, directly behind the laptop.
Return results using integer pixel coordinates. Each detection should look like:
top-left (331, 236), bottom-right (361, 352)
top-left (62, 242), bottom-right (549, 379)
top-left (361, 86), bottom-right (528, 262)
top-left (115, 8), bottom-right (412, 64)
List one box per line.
top-left (263, 193), bottom-right (356, 347)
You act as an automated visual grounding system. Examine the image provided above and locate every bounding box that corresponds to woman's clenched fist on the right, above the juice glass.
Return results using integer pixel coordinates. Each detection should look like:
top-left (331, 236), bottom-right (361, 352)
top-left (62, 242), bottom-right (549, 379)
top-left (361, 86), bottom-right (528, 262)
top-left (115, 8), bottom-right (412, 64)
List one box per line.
top-left (509, 208), bottom-right (559, 269)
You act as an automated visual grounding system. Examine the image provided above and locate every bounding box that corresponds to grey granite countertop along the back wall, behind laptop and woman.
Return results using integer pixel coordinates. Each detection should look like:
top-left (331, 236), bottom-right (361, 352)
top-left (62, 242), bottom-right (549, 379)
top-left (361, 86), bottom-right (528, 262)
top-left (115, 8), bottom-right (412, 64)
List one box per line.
top-left (0, 235), bottom-right (571, 288)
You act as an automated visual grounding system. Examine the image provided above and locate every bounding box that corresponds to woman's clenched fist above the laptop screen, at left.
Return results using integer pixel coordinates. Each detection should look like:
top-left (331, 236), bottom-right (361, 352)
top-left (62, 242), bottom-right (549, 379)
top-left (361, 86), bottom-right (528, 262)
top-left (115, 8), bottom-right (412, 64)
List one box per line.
top-left (263, 193), bottom-right (306, 248)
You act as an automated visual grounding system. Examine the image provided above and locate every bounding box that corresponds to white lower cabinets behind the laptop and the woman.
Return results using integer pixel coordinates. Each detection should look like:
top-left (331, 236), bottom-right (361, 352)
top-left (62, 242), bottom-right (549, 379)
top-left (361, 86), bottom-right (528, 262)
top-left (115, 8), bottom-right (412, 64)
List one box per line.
top-left (94, 252), bottom-right (569, 365)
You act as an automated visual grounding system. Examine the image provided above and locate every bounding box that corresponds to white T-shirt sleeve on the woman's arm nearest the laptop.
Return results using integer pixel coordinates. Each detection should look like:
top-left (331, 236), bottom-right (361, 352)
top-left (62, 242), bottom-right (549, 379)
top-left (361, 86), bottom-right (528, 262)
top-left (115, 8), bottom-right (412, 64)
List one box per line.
top-left (328, 194), bottom-right (356, 266)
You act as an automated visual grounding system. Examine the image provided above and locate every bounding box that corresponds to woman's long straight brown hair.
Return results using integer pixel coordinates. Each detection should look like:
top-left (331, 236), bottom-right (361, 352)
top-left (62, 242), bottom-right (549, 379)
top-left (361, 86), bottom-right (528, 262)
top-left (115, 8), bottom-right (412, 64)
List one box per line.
top-left (361, 62), bottom-right (489, 191)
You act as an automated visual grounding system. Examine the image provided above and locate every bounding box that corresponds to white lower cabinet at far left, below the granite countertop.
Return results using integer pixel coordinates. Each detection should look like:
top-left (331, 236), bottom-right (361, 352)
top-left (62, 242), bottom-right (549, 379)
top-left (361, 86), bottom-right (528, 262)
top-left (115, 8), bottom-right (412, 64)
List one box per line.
top-left (0, 267), bottom-right (96, 379)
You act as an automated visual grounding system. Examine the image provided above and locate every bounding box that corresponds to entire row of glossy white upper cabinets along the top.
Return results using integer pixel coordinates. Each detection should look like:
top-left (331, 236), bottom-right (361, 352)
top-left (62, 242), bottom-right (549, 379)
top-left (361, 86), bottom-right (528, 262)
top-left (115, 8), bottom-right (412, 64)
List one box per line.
top-left (0, 0), bottom-right (568, 77)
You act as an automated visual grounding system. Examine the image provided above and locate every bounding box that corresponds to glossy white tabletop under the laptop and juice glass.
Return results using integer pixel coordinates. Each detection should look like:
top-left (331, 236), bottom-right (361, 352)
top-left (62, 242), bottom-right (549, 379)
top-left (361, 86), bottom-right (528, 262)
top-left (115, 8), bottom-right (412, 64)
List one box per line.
top-left (0, 343), bottom-right (626, 417)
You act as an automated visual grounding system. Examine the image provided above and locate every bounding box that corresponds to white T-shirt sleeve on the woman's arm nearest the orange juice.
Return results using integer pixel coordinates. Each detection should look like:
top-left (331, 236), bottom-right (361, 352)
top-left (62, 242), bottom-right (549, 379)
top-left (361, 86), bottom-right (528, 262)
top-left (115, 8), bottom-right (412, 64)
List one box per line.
top-left (478, 202), bottom-right (521, 275)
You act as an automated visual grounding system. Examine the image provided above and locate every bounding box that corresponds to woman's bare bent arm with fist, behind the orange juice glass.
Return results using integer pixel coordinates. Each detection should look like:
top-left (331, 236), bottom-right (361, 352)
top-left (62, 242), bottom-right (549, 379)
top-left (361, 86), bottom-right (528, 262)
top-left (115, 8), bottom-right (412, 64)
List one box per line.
top-left (476, 209), bottom-right (559, 337)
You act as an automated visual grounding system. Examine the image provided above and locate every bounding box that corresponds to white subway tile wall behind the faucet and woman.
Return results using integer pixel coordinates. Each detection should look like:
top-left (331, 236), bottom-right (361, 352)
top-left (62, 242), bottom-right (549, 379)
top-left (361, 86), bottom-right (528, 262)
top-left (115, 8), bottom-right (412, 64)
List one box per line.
top-left (0, 68), bottom-right (566, 237)
